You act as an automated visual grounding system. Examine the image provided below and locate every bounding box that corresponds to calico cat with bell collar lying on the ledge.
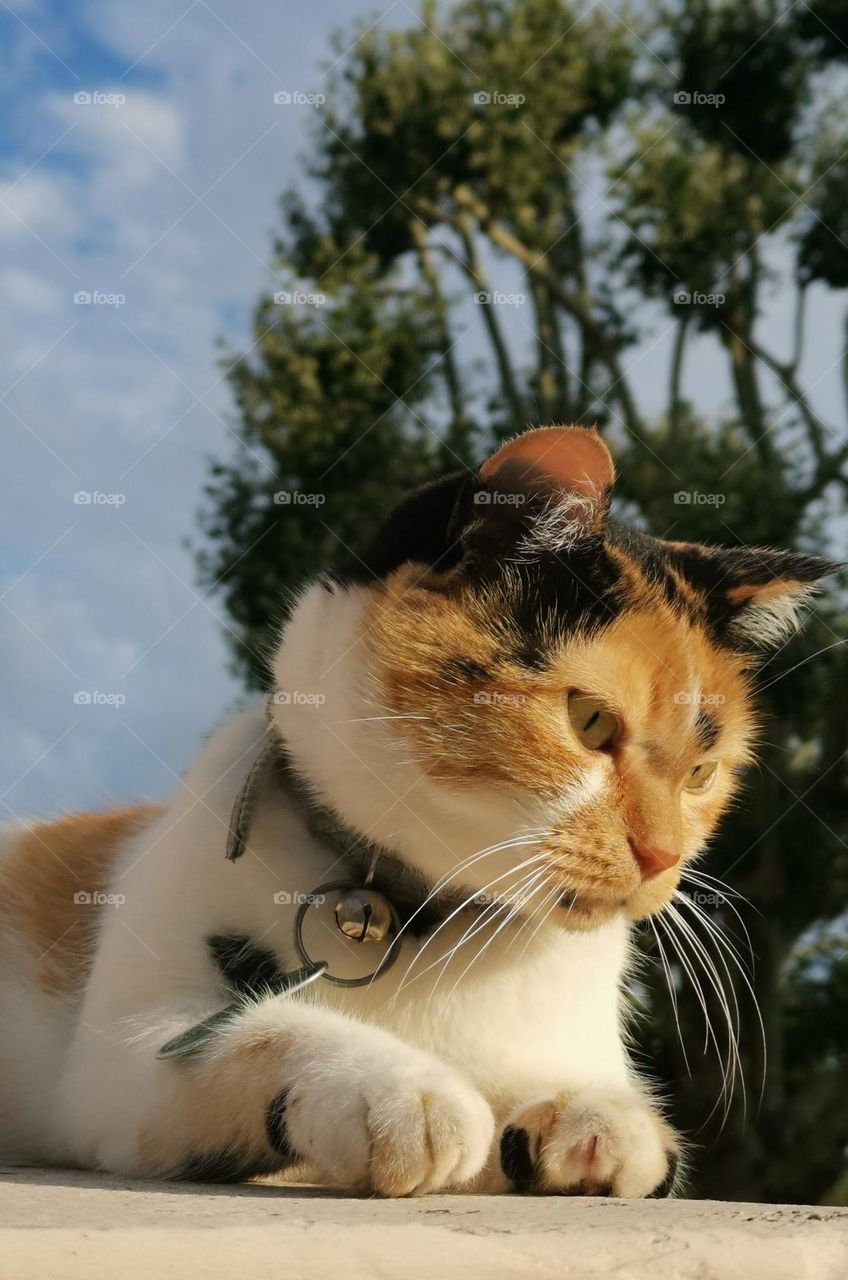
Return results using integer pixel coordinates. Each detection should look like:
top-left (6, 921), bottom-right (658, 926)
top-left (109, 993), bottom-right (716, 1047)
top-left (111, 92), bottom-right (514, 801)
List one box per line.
top-left (0, 428), bottom-right (835, 1197)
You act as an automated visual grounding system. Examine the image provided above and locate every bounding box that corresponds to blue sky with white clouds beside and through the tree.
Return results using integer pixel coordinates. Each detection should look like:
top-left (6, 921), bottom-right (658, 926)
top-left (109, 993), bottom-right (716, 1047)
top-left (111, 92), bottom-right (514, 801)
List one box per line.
top-left (0, 0), bottom-right (842, 820)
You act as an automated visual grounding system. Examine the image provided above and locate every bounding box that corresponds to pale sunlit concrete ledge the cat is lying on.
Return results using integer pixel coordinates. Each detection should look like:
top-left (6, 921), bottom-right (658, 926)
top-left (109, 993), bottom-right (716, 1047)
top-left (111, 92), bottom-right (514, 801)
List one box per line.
top-left (0, 1167), bottom-right (848, 1280)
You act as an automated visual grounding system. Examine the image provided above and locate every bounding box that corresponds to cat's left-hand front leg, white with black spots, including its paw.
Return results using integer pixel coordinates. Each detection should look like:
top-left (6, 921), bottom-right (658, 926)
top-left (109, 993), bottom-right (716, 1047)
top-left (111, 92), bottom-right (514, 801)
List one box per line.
top-left (60, 997), bottom-right (494, 1196)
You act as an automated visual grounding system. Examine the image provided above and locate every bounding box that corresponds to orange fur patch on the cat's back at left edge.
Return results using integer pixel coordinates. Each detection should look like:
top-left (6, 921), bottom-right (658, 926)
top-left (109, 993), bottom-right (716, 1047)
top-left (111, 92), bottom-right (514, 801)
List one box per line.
top-left (0, 805), bottom-right (161, 995)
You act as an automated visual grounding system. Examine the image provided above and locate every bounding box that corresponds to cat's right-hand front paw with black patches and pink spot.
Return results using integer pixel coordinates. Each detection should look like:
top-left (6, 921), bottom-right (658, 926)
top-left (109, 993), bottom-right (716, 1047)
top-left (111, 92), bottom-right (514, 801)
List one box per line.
top-left (501, 1089), bottom-right (678, 1197)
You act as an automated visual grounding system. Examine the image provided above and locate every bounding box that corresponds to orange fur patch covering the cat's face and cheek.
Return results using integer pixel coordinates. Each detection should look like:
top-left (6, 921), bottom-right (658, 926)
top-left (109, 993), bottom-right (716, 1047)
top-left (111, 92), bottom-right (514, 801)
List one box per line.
top-left (365, 553), bottom-right (754, 928)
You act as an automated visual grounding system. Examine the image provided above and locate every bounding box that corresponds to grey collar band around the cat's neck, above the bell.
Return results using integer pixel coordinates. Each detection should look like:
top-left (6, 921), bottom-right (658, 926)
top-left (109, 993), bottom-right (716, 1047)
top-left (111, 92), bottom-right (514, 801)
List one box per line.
top-left (227, 698), bottom-right (471, 937)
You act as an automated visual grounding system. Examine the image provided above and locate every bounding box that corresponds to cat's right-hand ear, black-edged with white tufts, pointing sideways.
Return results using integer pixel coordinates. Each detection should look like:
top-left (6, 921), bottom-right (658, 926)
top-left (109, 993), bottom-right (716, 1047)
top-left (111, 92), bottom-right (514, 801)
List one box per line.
top-left (676, 544), bottom-right (842, 649)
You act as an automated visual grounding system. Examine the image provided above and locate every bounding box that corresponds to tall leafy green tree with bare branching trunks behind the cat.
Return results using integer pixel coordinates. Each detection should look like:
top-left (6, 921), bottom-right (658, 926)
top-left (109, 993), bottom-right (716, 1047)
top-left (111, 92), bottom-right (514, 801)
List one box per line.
top-left (201, 0), bottom-right (848, 1201)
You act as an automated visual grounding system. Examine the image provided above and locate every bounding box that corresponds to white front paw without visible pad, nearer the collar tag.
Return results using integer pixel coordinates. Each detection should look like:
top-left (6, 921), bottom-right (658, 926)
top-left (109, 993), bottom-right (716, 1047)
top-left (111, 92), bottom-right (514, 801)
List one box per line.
top-left (286, 1053), bottom-right (494, 1196)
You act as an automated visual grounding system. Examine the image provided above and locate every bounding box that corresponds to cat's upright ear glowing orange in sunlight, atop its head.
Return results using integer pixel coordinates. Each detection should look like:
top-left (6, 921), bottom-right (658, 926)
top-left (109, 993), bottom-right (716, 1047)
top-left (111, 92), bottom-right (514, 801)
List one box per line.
top-left (475, 426), bottom-right (615, 554)
